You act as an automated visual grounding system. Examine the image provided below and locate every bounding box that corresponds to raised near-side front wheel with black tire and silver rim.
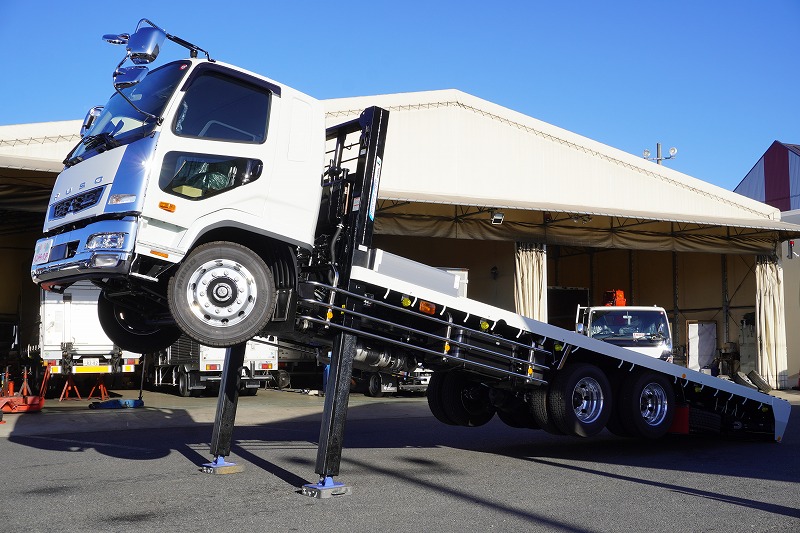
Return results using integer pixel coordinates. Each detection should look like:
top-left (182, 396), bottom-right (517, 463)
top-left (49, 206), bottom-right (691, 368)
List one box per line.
top-left (167, 242), bottom-right (276, 347)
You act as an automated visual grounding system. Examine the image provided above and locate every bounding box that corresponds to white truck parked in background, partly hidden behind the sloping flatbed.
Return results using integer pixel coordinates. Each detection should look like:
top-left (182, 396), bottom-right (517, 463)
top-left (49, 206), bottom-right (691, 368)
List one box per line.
top-left (575, 305), bottom-right (673, 363)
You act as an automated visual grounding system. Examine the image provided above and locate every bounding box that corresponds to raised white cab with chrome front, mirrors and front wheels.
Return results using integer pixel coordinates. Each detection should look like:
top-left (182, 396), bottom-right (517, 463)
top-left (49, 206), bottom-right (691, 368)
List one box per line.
top-left (31, 19), bottom-right (326, 353)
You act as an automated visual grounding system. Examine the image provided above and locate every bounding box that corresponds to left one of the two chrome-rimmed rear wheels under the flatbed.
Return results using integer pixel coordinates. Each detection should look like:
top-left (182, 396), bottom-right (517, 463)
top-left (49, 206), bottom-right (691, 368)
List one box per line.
top-left (547, 363), bottom-right (612, 437)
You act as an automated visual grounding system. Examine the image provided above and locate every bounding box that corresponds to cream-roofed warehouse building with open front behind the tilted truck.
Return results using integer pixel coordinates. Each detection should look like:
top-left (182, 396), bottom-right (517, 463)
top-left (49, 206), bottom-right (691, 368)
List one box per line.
top-left (0, 90), bottom-right (800, 387)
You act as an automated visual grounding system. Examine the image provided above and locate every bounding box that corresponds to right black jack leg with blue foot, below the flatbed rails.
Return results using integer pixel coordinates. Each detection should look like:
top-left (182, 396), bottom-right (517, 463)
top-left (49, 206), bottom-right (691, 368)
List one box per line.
top-left (302, 333), bottom-right (356, 498)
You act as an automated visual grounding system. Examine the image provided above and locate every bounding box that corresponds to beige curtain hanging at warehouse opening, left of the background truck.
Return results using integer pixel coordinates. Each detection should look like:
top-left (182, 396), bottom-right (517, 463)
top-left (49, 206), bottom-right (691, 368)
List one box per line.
top-left (514, 242), bottom-right (547, 322)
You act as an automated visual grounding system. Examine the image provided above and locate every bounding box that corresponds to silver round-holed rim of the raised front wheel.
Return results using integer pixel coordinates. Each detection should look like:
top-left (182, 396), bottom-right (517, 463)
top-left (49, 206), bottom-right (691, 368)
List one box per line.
top-left (186, 259), bottom-right (258, 327)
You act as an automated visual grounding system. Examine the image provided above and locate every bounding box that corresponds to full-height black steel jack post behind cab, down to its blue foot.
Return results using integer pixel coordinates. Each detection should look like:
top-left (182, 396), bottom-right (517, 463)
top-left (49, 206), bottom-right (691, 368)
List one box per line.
top-left (303, 107), bottom-right (389, 497)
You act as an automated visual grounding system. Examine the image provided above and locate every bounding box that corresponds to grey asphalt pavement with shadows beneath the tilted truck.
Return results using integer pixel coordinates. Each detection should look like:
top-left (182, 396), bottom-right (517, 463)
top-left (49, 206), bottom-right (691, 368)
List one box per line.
top-left (0, 389), bottom-right (800, 533)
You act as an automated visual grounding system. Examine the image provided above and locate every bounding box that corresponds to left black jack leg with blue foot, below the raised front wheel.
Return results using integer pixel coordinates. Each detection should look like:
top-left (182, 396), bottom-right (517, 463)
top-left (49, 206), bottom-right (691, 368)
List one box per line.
top-left (201, 343), bottom-right (247, 474)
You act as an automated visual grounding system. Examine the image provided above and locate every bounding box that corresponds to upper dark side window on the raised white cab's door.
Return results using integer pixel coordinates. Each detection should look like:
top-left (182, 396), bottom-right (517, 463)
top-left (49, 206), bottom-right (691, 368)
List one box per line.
top-left (173, 72), bottom-right (270, 144)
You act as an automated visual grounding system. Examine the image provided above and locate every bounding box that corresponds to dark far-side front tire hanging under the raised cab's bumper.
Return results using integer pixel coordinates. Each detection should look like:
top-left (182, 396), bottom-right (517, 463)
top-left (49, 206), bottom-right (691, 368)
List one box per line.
top-left (97, 292), bottom-right (181, 354)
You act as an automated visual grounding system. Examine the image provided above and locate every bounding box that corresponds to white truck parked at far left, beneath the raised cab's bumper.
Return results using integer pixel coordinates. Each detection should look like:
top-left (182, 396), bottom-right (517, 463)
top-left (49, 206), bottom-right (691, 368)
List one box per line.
top-left (35, 281), bottom-right (139, 375)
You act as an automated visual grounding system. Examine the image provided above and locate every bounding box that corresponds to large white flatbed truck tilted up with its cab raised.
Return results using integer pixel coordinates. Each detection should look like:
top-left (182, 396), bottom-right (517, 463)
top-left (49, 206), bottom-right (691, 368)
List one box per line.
top-left (31, 19), bottom-right (790, 487)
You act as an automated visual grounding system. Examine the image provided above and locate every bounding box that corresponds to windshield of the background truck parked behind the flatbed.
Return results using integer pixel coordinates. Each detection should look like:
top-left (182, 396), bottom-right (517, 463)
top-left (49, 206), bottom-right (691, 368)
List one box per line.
top-left (589, 308), bottom-right (669, 346)
